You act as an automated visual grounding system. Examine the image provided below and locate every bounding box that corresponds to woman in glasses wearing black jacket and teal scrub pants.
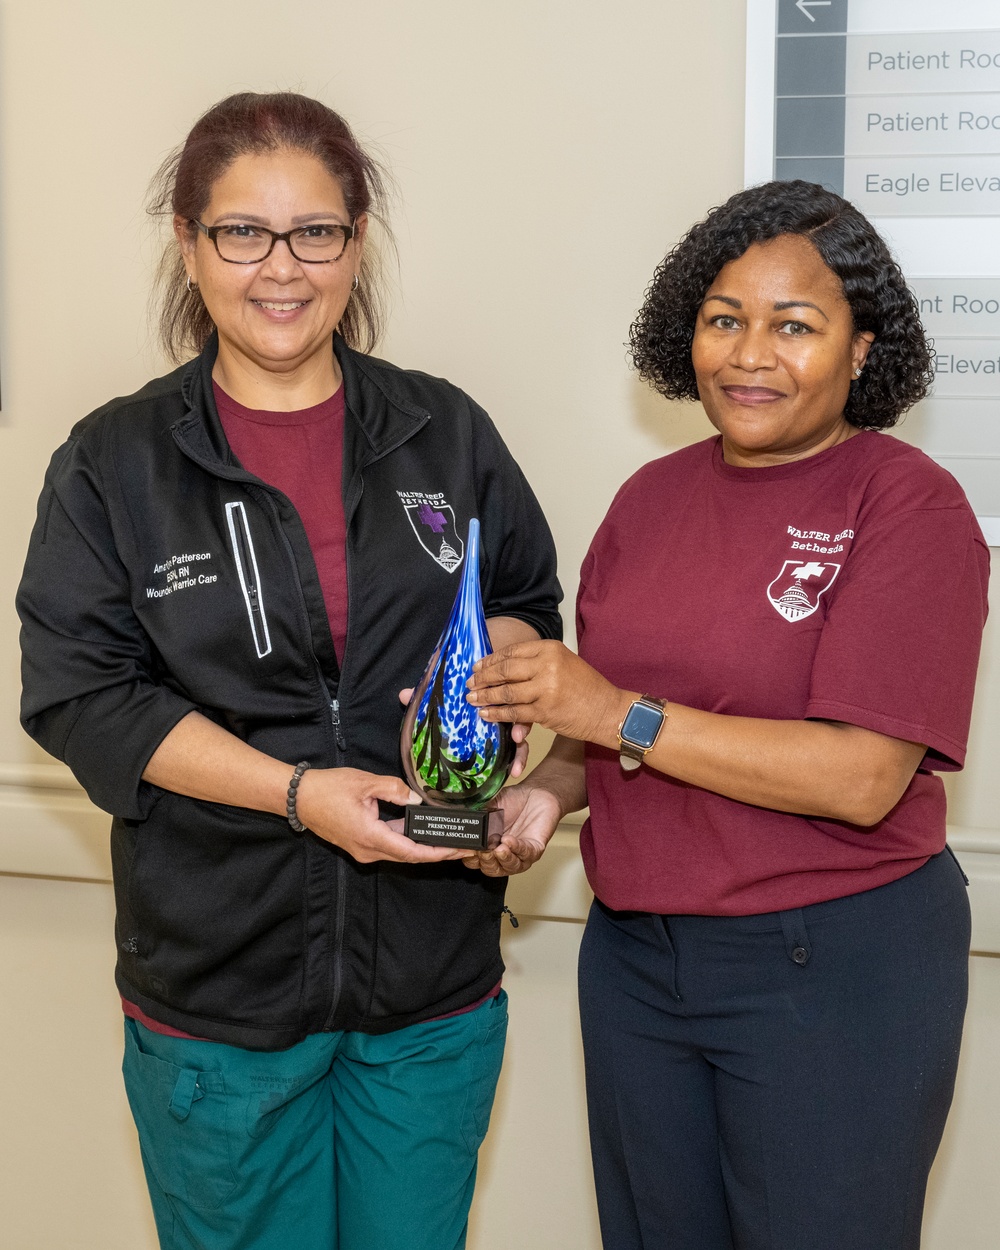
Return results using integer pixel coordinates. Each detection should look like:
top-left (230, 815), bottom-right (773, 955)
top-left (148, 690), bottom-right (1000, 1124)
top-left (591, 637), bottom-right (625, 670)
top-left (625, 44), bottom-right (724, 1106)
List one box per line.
top-left (19, 93), bottom-right (560, 1250)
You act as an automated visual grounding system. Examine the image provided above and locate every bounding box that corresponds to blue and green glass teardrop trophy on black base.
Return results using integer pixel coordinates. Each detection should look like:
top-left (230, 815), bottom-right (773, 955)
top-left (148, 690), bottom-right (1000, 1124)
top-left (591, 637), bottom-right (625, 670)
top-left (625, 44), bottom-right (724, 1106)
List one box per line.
top-left (400, 520), bottom-right (515, 850)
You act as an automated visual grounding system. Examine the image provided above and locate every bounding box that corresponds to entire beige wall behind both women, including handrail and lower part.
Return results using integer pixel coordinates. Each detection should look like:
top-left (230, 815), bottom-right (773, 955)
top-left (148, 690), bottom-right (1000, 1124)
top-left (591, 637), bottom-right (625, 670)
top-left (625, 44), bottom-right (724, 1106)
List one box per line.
top-left (0, 0), bottom-right (1000, 1250)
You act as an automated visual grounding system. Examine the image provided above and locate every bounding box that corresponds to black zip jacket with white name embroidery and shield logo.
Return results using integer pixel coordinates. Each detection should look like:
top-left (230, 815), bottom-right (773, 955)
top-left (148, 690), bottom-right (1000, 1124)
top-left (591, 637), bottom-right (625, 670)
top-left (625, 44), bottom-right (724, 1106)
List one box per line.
top-left (18, 339), bottom-right (560, 1050)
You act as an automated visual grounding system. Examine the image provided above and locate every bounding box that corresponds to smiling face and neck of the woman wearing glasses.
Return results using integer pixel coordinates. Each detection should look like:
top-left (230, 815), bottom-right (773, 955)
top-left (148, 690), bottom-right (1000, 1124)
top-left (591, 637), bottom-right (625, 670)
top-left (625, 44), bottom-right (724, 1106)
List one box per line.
top-left (174, 149), bottom-right (366, 398)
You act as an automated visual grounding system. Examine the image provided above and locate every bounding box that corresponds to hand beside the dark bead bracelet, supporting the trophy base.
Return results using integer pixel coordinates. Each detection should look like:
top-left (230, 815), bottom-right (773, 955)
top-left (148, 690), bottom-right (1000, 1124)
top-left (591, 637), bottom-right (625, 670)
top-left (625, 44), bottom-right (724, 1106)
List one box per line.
top-left (296, 769), bottom-right (469, 864)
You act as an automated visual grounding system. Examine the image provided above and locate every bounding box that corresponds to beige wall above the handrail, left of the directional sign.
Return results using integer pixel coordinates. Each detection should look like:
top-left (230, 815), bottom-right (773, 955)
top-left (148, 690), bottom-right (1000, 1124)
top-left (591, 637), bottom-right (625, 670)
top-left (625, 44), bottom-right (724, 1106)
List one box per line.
top-left (0, 0), bottom-right (743, 763)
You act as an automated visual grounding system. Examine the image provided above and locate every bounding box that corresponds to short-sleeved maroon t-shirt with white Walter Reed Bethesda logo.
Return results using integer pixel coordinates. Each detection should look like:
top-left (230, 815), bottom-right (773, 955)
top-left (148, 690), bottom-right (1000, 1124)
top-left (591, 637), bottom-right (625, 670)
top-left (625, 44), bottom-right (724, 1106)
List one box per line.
top-left (578, 433), bottom-right (989, 915)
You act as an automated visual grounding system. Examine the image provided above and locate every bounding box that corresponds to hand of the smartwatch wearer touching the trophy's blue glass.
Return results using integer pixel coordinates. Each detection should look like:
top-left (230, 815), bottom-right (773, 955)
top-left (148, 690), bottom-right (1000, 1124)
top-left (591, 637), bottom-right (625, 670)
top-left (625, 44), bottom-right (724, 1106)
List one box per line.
top-left (468, 641), bottom-right (620, 746)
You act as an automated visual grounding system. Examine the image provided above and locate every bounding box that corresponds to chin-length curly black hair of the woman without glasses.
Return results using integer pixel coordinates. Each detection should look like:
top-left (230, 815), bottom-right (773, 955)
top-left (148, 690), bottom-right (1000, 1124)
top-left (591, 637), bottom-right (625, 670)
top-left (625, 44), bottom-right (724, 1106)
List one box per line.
top-left (629, 180), bottom-right (934, 430)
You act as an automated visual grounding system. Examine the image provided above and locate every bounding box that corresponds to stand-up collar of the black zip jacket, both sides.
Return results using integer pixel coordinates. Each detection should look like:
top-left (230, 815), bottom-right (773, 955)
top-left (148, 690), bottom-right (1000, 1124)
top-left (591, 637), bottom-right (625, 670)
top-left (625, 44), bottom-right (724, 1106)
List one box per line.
top-left (173, 333), bottom-right (430, 479)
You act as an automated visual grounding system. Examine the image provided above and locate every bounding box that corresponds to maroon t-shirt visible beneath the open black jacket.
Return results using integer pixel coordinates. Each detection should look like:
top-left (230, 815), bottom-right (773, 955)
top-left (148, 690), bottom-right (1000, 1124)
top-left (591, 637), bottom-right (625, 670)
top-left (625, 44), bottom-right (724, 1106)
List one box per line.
top-left (213, 383), bottom-right (348, 663)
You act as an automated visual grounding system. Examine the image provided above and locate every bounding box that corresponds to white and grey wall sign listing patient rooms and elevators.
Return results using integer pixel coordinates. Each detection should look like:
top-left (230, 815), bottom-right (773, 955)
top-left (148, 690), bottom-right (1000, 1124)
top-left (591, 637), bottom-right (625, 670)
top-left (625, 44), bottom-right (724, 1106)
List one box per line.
top-left (746, 0), bottom-right (1000, 545)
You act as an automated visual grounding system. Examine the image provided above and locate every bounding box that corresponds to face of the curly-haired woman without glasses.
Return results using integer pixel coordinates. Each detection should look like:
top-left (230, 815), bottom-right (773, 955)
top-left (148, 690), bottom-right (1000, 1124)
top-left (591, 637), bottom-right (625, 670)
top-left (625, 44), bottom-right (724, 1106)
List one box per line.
top-left (691, 235), bottom-right (875, 468)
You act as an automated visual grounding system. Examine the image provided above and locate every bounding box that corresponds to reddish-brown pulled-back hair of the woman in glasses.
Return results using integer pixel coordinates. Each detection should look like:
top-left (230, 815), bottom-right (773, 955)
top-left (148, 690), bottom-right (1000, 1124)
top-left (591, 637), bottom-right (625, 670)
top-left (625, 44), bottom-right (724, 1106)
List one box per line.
top-left (148, 91), bottom-right (393, 360)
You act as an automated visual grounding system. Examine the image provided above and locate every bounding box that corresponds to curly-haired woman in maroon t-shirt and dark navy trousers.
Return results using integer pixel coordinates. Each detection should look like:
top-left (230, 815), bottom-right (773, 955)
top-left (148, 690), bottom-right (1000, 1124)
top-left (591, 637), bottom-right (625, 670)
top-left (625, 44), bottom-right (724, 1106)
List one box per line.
top-left (470, 183), bottom-right (988, 1250)
